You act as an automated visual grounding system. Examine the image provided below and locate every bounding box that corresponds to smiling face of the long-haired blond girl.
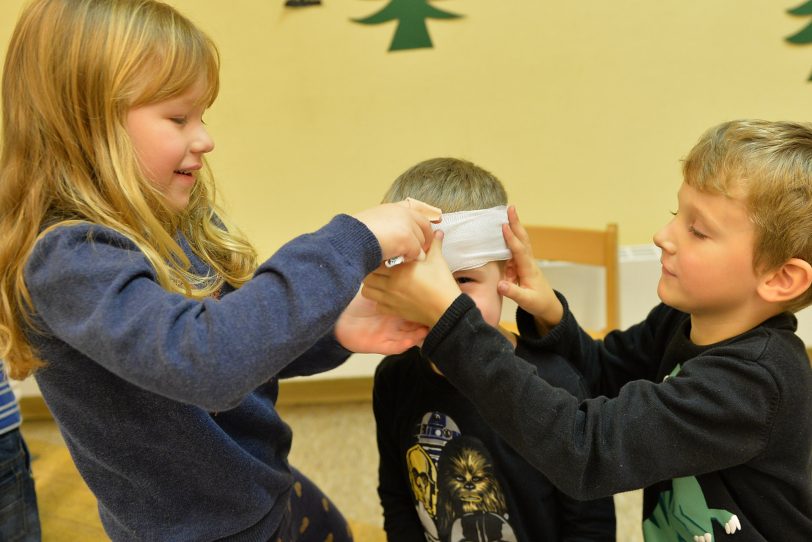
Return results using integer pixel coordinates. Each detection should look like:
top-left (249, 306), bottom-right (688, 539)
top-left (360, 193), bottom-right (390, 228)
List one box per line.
top-left (126, 81), bottom-right (214, 211)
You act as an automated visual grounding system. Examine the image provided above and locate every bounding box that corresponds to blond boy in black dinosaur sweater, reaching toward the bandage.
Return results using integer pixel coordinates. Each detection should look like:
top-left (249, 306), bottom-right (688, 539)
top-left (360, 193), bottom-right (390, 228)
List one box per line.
top-left (365, 120), bottom-right (812, 542)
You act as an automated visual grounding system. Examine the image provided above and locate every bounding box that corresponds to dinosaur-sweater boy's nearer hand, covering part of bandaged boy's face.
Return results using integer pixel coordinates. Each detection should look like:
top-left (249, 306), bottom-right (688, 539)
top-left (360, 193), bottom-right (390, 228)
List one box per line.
top-left (361, 232), bottom-right (461, 327)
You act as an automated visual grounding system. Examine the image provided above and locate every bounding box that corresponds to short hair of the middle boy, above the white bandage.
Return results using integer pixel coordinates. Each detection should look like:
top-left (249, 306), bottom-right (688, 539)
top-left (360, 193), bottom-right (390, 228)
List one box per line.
top-left (383, 158), bottom-right (507, 213)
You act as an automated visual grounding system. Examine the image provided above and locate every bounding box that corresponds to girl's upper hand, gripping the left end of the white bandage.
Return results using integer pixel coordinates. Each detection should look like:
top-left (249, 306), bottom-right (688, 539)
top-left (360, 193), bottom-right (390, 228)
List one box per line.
top-left (354, 200), bottom-right (440, 262)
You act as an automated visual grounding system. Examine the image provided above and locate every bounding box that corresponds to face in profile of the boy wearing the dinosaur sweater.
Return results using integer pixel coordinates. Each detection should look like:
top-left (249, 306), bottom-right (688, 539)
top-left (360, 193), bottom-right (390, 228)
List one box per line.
top-left (654, 183), bottom-right (758, 322)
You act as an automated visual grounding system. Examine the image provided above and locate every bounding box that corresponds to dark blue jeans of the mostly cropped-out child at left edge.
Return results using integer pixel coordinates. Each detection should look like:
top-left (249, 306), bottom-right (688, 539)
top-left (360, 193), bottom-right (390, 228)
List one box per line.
top-left (0, 429), bottom-right (41, 542)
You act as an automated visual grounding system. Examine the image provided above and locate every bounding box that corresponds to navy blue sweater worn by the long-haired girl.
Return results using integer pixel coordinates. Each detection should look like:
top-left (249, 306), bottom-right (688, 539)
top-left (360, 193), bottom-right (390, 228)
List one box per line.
top-left (25, 215), bottom-right (381, 542)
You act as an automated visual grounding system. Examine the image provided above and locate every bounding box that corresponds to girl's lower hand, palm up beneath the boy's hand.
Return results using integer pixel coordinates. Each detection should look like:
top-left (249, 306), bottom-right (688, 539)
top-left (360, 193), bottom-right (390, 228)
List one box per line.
top-left (335, 290), bottom-right (429, 356)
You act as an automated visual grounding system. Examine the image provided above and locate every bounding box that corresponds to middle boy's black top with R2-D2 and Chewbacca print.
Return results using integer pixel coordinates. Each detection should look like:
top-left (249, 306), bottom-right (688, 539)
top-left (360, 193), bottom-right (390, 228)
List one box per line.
top-left (373, 342), bottom-right (615, 542)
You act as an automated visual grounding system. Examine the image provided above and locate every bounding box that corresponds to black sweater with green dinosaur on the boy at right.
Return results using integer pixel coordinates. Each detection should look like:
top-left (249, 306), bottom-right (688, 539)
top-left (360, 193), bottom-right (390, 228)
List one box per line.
top-left (423, 296), bottom-right (812, 542)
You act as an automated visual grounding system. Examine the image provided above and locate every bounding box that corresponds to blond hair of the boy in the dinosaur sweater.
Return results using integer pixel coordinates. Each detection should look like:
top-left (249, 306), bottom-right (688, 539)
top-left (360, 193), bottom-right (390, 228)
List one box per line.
top-left (683, 120), bottom-right (812, 312)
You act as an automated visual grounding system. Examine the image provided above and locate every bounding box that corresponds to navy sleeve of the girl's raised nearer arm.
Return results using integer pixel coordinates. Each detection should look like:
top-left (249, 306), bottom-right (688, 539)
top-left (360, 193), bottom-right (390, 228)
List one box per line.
top-left (25, 215), bottom-right (380, 410)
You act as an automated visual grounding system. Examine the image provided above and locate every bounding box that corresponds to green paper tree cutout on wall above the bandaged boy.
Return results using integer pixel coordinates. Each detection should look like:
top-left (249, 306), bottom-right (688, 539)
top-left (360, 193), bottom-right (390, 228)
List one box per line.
top-left (353, 0), bottom-right (462, 51)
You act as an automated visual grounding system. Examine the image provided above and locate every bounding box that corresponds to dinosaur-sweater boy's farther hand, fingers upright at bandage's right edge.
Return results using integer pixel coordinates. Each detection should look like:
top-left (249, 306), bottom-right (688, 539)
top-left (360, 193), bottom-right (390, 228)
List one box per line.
top-left (498, 205), bottom-right (564, 332)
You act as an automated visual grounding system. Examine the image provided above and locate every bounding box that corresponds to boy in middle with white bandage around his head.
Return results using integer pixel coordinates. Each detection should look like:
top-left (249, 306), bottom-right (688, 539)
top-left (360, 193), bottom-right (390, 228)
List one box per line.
top-left (373, 158), bottom-right (615, 542)
